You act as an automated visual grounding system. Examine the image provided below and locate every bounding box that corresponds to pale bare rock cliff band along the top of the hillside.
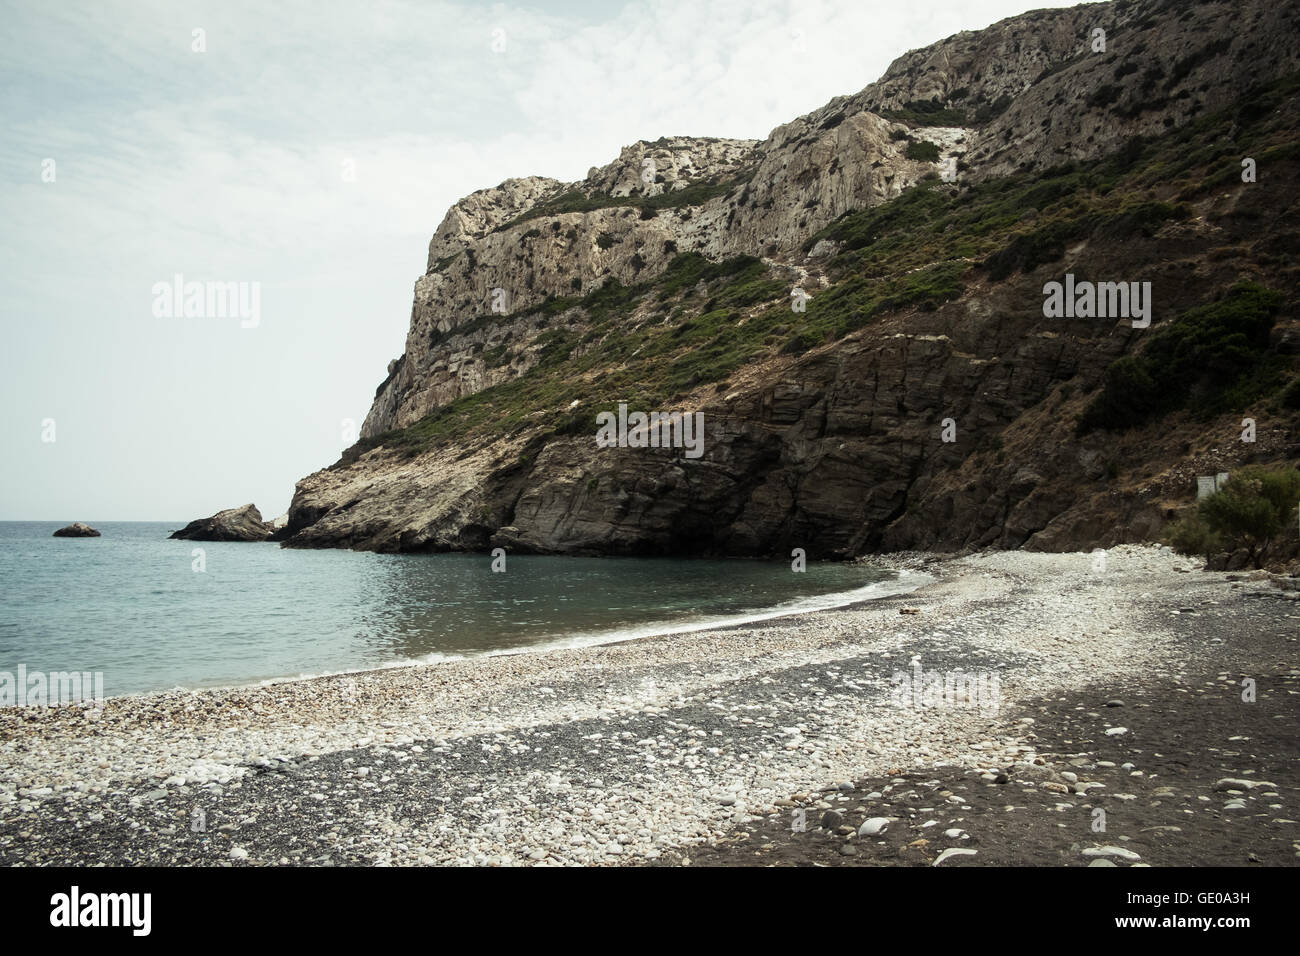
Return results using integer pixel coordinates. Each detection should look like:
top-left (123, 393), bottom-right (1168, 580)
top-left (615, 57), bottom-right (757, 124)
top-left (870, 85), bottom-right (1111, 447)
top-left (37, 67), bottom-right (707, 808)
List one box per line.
top-left (361, 0), bottom-right (1300, 437)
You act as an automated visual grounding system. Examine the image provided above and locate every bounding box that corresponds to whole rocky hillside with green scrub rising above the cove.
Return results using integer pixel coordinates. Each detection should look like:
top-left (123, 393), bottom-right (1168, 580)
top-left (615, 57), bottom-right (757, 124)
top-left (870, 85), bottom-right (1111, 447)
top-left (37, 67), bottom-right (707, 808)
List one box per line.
top-left (285, 0), bottom-right (1300, 557)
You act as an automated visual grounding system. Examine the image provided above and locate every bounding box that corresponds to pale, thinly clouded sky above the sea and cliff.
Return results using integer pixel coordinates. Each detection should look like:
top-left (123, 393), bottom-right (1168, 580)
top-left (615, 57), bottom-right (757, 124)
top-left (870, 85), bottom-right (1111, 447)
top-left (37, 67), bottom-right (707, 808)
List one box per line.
top-left (0, 0), bottom-right (1071, 523)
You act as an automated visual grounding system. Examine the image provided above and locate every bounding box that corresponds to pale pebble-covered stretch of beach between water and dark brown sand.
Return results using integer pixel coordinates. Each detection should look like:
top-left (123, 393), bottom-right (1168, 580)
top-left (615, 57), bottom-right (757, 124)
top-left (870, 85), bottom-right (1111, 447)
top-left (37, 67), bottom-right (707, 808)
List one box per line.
top-left (0, 545), bottom-right (1300, 865)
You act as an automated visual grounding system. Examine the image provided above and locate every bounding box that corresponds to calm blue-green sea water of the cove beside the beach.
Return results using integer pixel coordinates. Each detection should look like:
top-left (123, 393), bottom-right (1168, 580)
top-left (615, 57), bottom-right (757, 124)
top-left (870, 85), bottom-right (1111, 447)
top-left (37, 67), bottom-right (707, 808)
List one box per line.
top-left (0, 522), bottom-right (897, 696)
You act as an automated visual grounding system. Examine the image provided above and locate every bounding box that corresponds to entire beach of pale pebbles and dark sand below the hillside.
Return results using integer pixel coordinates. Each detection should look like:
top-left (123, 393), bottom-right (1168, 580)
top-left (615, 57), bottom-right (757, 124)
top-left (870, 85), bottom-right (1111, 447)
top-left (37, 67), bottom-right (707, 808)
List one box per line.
top-left (0, 545), bottom-right (1300, 866)
